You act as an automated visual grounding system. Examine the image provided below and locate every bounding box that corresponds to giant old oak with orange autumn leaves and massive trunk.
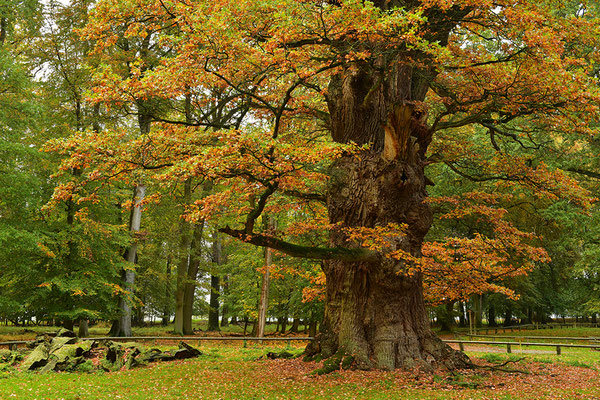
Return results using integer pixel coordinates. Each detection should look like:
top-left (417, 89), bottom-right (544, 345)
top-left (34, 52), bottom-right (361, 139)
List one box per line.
top-left (67, 0), bottom-right (600, 369)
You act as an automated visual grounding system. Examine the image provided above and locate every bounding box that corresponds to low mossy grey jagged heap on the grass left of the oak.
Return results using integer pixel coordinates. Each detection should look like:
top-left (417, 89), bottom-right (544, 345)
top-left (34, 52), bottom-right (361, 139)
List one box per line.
top-left (11, 329), bottom-right (202, 372)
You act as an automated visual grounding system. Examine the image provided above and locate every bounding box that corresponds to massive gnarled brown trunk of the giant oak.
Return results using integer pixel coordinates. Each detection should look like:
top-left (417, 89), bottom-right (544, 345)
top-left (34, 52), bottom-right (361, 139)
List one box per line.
top-left (306, 55), bottom-right (469, 370)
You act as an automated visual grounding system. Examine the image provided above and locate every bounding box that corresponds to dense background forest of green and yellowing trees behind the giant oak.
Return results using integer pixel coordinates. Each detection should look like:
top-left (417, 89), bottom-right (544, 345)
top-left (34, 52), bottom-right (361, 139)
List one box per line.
top-left (0, 0), bottom-right (600, 335)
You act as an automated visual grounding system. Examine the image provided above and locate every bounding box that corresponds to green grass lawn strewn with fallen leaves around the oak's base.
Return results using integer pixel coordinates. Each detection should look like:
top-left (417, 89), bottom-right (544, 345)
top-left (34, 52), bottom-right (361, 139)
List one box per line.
top-left (0, 328), bottom-right (600, 400)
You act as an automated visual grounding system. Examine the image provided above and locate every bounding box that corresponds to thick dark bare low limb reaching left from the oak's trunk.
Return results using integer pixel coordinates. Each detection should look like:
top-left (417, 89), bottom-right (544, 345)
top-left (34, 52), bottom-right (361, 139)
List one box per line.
top-left (219, 226), bottom-right (378, 262)
